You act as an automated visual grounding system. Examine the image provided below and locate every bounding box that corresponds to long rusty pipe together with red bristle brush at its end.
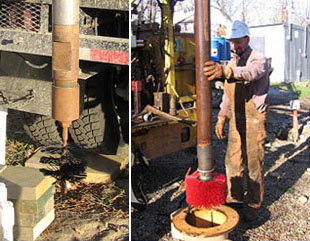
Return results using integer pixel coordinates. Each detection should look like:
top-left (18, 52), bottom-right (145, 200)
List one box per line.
top-left (185, 0), bottom-right (226, 209)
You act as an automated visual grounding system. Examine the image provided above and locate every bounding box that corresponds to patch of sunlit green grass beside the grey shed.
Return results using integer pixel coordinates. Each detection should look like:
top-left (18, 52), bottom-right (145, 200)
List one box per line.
top-left (270, 81), bottom-right (310, 98)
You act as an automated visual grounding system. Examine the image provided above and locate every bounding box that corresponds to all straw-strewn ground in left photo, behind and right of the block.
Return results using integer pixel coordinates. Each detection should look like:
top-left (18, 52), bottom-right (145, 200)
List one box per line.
top-left (6, 110), bottom-right (129, 241)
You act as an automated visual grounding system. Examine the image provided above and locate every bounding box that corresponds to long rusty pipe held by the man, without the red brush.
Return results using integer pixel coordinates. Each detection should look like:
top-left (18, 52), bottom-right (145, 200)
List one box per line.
top-left (195, 0), bottom-right (214, 181)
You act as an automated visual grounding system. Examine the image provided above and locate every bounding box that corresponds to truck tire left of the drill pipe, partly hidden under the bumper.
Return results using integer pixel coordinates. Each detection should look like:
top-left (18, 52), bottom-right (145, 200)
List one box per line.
top-left (24, 112), bottom-right (62, 145)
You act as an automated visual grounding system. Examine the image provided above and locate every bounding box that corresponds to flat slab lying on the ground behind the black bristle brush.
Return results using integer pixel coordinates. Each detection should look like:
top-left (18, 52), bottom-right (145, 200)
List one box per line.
top-left (25, 144), bottom-right (129, 183)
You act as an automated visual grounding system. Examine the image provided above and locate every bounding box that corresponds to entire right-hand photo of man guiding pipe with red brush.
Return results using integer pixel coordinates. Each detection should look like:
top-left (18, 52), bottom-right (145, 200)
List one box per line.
top-left (130, 0), bottom-right (310, 241)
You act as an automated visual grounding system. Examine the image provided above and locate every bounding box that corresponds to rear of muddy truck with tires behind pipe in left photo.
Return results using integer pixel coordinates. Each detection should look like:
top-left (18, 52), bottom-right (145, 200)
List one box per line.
top-left (0, 0), bottom-right (129, 154)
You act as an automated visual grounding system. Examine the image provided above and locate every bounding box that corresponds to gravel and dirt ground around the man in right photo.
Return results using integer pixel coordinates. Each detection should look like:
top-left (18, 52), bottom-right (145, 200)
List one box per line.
top-left (131, 88), bottom-right (310, 241)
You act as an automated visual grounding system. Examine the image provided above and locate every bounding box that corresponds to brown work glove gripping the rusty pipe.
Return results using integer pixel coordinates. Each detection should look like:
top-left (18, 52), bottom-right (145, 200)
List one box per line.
top-left (203, 61), bottom-right (232, 81)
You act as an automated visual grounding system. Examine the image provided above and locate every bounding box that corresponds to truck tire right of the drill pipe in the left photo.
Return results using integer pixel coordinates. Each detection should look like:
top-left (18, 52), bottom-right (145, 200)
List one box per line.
top-left (69, 69), bottom-right (120, 155)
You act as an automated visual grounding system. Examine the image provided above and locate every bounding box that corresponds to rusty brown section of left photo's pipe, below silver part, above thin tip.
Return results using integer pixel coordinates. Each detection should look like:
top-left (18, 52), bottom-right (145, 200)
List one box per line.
top-left (52, 24), bottom-right (80, 122)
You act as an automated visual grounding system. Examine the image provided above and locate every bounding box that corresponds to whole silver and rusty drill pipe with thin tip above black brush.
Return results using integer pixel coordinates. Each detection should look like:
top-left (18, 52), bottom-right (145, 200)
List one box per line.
top-left (52, 0), bottom-right (80, 147)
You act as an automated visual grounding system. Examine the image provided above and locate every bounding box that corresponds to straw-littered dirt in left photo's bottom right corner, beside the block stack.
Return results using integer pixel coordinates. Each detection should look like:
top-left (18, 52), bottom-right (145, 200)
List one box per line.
top-left (36, 177), bottom-right (129, 241)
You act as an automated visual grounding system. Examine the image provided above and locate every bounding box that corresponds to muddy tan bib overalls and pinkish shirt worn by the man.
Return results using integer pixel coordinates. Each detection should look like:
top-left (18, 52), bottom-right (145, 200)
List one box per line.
top-left (219, 48), bottom-right (269, 208)
